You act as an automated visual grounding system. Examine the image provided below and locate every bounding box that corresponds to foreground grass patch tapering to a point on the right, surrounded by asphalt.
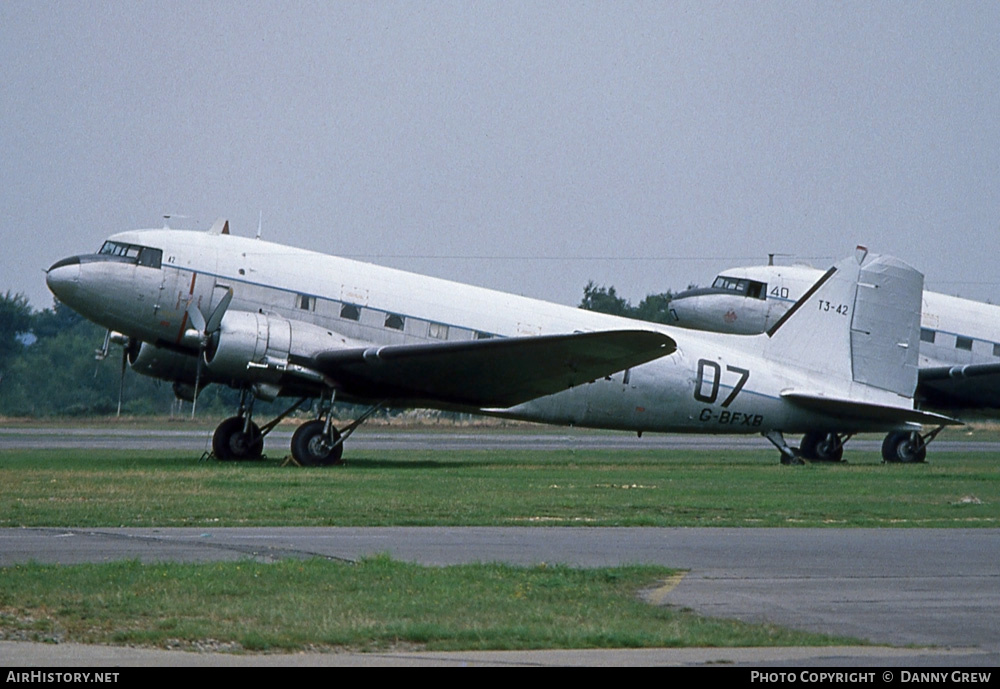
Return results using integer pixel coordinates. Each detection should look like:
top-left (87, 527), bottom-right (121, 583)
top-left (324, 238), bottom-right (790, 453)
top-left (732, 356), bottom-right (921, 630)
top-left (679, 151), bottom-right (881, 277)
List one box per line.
top-left (0, 557), bottom-right (857, 652)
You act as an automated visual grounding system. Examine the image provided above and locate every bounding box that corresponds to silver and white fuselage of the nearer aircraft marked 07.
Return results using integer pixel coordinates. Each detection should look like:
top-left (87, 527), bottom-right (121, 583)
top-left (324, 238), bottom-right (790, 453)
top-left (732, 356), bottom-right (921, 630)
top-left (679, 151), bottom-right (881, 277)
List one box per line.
top-left (47, 229), bottom-right (913, 433)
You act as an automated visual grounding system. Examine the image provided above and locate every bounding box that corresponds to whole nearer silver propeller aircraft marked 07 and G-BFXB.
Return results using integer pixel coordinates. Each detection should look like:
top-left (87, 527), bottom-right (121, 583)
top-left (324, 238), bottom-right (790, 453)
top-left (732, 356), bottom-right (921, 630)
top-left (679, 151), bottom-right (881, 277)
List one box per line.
top-left (46, 220), bottom-right (954, 465)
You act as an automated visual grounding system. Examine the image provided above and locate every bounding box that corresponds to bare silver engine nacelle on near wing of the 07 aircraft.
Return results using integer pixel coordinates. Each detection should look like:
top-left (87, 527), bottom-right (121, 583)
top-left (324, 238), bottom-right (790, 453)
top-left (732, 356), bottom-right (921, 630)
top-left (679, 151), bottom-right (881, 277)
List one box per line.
top-left (205, 311), bottom-right (348, 385)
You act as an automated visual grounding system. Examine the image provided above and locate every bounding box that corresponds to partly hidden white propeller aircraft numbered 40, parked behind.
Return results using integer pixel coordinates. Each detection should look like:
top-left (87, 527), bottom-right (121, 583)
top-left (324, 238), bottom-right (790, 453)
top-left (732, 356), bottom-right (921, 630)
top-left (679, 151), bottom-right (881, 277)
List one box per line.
top-left (670, 265), bottom-right (1000, 454)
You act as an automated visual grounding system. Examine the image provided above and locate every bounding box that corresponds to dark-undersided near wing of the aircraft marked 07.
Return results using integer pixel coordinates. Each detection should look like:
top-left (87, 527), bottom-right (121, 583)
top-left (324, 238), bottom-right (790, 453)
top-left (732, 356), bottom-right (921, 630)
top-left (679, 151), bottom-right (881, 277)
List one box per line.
top-left (308, 330), bottom-right (676, 408)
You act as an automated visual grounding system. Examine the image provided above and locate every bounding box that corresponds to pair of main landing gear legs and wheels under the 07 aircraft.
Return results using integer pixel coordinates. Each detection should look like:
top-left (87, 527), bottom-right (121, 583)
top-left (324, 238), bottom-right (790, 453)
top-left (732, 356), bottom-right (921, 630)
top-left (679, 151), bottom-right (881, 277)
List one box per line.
top-left (212, 389), bottom-right (385, 466)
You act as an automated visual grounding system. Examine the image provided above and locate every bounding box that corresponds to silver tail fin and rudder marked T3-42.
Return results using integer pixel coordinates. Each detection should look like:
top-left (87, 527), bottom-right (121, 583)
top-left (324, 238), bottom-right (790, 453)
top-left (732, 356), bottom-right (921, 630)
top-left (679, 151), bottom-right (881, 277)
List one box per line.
top-left (767, 247), bottom-right (924, 398)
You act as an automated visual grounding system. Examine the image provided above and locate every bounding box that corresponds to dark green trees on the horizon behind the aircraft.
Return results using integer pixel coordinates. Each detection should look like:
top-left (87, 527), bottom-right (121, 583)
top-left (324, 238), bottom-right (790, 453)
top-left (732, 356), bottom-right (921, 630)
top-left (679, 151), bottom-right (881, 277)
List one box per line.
top-left (0, 282), bottom-right (671, 418)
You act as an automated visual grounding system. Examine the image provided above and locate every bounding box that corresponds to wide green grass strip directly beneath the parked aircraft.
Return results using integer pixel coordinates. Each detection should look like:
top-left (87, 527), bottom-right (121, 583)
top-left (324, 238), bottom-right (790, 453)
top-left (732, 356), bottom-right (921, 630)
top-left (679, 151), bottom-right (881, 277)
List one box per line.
top-left (0, 450), bottom-right (1000, 527)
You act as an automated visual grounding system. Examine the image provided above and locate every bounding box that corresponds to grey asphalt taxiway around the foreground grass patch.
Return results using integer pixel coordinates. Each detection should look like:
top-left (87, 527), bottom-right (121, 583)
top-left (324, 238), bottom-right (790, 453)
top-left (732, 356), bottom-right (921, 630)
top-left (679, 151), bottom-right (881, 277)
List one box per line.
top-left (0, 527), bottom-right (1000, 666)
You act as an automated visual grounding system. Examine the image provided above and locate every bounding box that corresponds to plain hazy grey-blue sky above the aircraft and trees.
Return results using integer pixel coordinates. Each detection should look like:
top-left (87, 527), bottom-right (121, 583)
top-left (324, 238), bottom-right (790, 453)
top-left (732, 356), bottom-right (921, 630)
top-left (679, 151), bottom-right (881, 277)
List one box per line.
top-left (0, 0), bottom-right (1000, 308)
